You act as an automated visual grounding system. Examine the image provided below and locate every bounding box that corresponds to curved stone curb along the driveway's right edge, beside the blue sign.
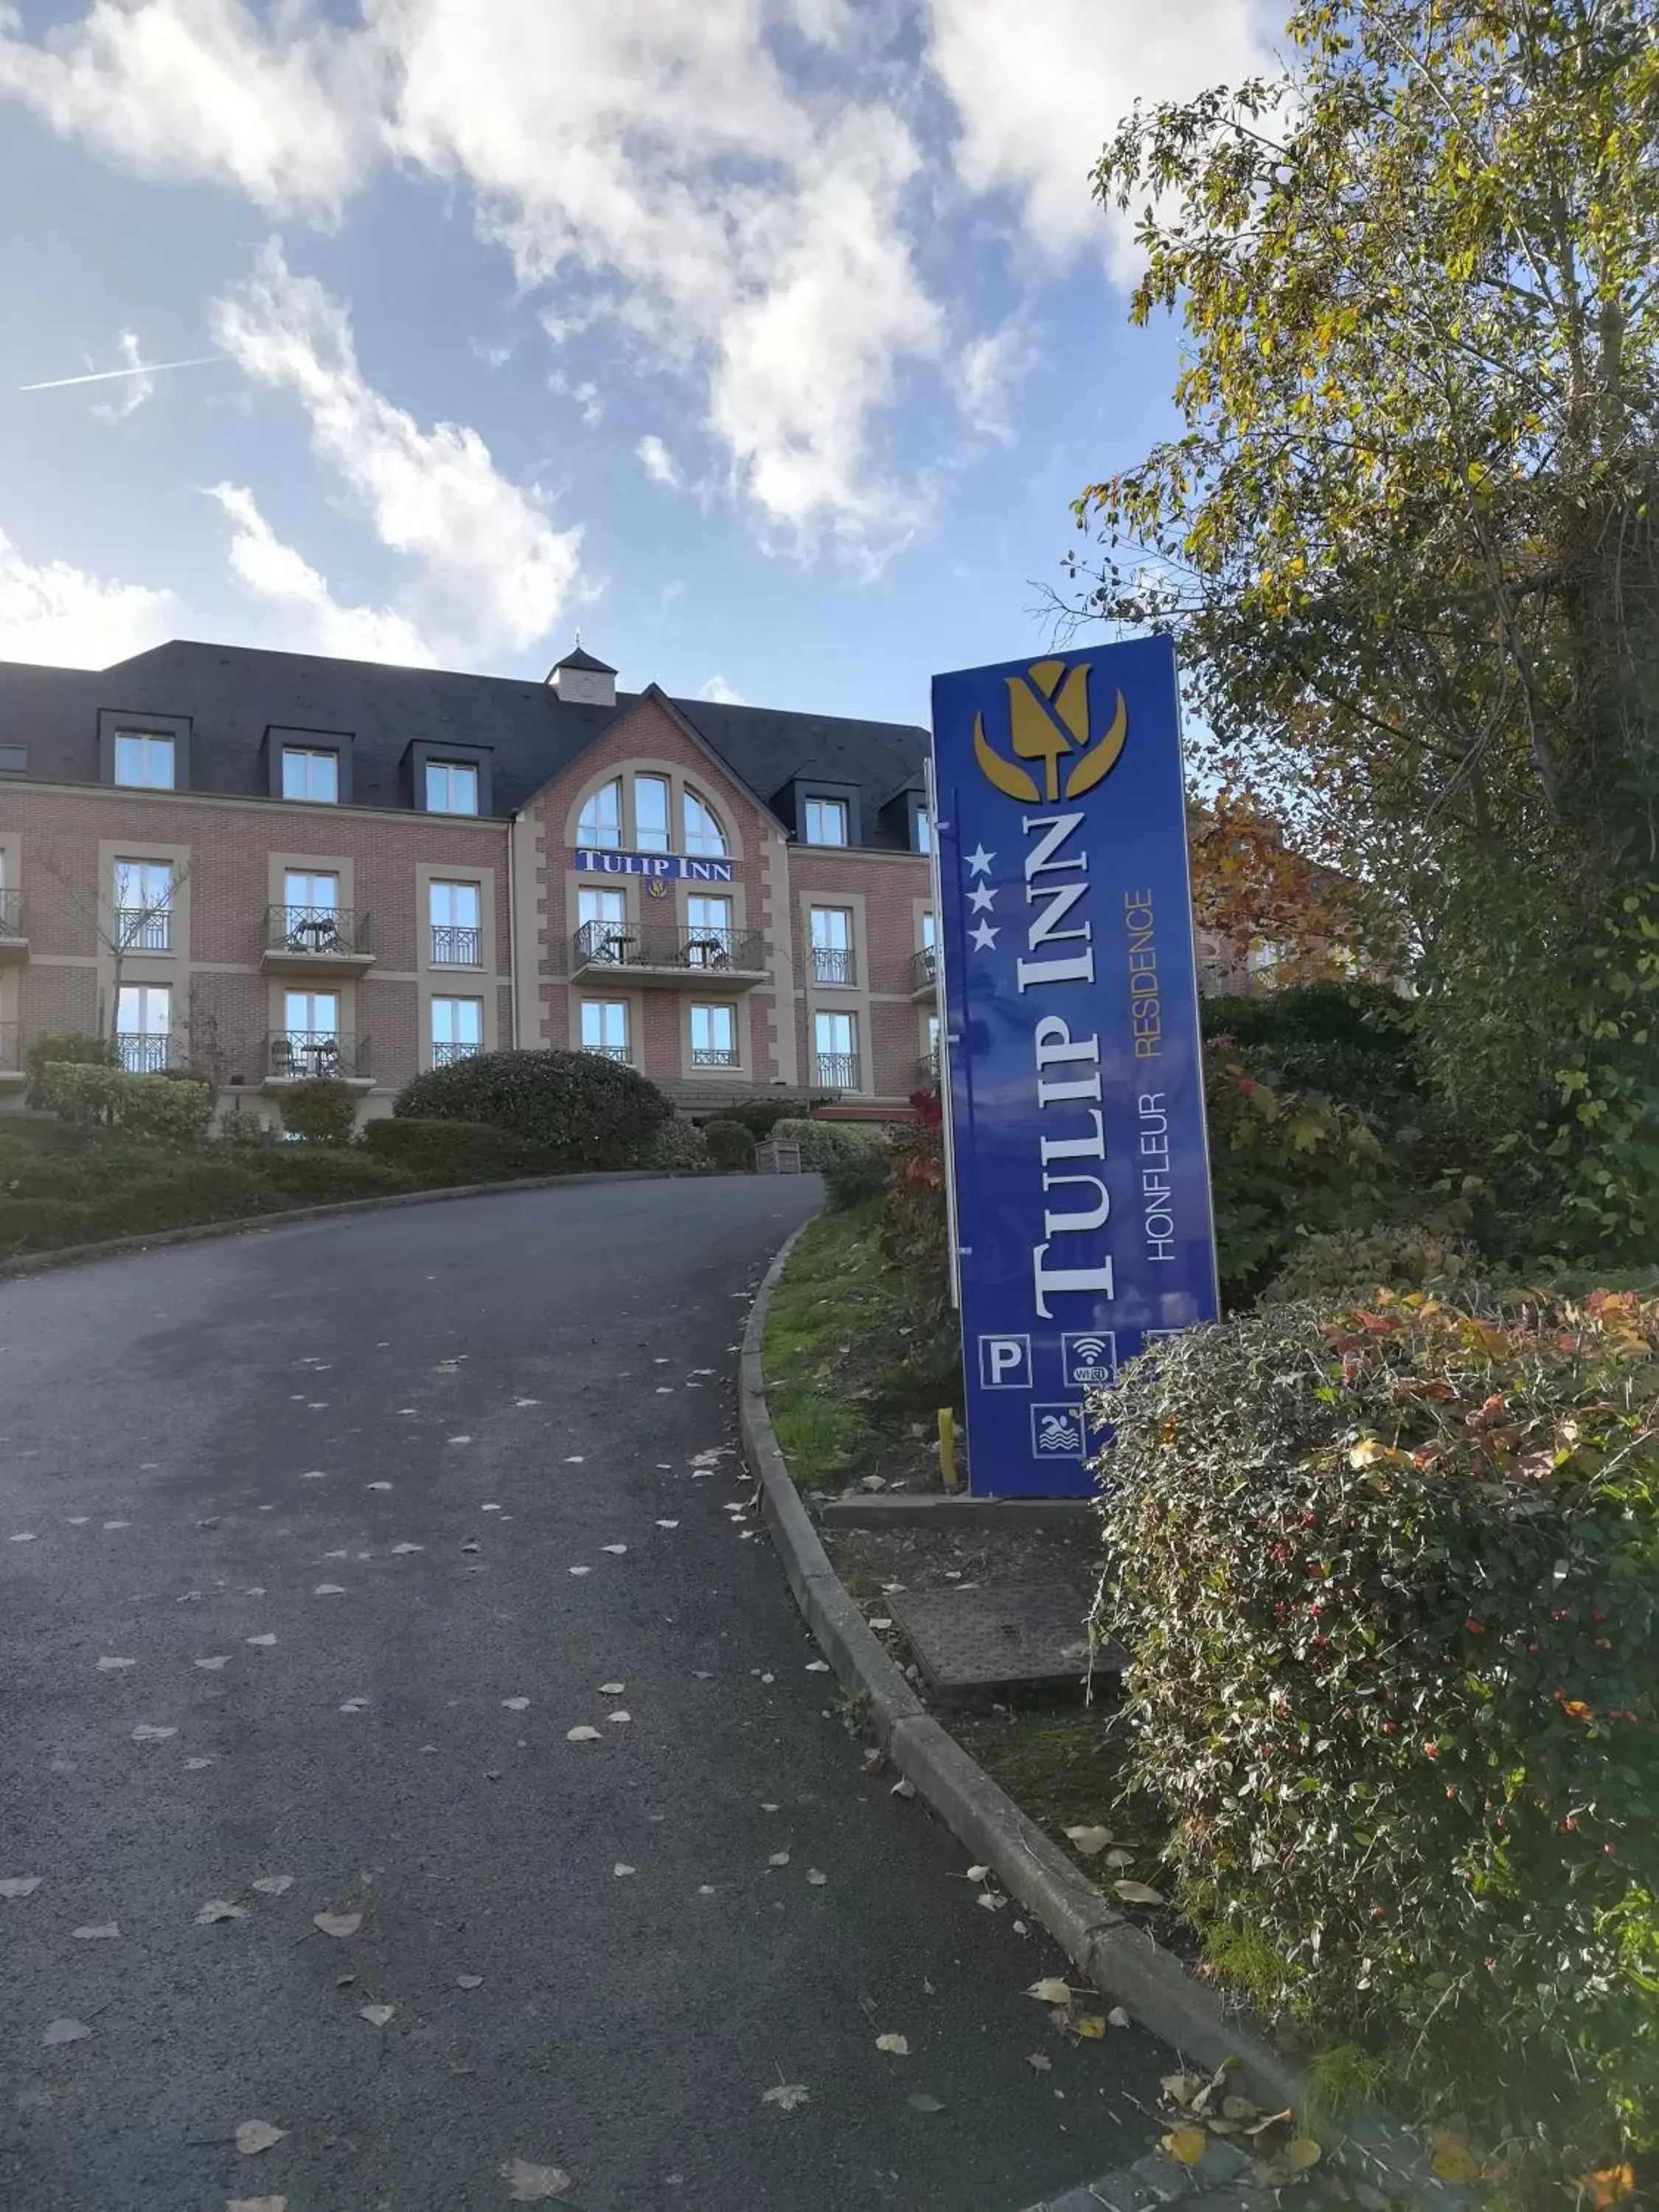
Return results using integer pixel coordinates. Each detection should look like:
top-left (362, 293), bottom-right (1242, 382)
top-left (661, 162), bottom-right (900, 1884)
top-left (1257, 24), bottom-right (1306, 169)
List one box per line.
top-left (737, 1230), bottom-right (1307, 2110)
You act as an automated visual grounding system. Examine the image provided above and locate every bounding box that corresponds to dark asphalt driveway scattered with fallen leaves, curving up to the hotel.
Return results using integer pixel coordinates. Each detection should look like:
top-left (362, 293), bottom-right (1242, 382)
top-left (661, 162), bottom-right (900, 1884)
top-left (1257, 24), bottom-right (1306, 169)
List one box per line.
top-left (0, 1179), bottom-right (1168, 2212)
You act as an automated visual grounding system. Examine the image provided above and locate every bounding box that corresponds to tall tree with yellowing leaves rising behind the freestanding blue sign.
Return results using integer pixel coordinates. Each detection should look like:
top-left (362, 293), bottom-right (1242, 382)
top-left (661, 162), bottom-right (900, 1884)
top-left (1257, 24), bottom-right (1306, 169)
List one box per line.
top-left (1073, 0), bottom-right (1659, 1250)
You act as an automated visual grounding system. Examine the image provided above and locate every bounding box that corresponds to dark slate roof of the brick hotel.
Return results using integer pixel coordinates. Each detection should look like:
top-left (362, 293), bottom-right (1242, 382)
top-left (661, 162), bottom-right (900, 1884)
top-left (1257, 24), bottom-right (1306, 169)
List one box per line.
top-left (0, 639), bottom-right (927, 847)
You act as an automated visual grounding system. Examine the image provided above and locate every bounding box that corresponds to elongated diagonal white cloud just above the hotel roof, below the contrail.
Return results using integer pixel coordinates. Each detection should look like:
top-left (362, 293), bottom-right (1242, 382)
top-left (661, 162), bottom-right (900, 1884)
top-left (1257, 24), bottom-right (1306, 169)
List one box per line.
top-left (212, 243), bottom-right (582, 657)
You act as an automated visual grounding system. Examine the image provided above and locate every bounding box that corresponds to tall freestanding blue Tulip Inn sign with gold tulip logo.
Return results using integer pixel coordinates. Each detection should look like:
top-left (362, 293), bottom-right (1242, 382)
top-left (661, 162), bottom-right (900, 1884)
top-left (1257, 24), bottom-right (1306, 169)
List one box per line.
top-left (933, 637), bottom-right (1217, 1498)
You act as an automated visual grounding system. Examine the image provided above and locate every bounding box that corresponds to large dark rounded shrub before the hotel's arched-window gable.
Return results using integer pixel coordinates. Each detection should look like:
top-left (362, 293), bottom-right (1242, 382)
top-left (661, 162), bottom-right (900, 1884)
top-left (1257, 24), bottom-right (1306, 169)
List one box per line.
top-left (392, 1051), bottom-right (675, 1172)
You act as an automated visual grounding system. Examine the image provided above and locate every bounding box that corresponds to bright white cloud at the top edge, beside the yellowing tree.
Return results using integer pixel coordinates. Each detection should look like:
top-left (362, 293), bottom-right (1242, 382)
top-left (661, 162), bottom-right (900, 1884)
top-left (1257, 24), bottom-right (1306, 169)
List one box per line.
top-left (929, 0), bottom-right (1283, 276)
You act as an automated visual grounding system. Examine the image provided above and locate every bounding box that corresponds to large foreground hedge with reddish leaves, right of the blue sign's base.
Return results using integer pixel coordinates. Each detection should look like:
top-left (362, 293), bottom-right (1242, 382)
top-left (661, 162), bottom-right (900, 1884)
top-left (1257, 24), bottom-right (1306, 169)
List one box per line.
top-left (1095, 1292), bottom-right (1659, 2168)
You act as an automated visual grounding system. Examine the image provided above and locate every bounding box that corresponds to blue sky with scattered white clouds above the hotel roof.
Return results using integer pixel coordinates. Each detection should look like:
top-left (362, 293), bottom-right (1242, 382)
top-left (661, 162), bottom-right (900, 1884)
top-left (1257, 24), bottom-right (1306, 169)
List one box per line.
top-left (0, 0), bottom-right (1272, 721)
